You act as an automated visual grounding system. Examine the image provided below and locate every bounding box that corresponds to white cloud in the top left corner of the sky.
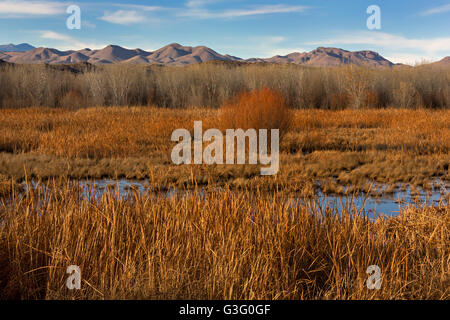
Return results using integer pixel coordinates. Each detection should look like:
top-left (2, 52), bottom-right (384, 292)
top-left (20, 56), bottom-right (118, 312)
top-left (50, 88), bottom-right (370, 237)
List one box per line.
top-left (0, 0), bottom-right (66, 18)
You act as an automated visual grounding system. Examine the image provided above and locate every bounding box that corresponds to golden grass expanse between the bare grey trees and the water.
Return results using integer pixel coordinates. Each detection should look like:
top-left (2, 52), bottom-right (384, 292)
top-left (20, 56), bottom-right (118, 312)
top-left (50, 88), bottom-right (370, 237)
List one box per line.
top-left (0, 107), bottom-right (450, 194)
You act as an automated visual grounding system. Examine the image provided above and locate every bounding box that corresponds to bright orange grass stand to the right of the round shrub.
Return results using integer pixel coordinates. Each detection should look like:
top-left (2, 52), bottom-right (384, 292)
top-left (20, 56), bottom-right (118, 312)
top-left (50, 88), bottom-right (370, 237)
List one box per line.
top-left (291, 109), bottom-right (450, 154)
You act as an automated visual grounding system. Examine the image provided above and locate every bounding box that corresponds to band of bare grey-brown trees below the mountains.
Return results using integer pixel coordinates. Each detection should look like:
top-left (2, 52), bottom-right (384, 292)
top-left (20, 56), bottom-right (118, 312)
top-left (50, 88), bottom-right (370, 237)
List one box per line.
top-left (0, 63), bottom-right (450, 109)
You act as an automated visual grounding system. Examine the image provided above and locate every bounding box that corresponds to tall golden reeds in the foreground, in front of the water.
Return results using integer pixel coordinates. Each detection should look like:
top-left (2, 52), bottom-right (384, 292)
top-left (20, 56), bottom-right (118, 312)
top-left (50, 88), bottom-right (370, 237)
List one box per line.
top-left (0, 180), bottom-right (450, 300)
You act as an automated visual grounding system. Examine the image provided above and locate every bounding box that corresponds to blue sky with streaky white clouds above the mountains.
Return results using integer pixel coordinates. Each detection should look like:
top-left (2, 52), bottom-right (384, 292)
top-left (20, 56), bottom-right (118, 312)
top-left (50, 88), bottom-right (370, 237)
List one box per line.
top-left (0, 0), bottom-right (450, 63)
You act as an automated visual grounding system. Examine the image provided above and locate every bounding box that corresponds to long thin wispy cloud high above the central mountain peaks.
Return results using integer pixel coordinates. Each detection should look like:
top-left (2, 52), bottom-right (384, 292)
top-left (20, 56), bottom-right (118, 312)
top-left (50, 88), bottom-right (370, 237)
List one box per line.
top-left (178, 1), bottom-right (309, 19)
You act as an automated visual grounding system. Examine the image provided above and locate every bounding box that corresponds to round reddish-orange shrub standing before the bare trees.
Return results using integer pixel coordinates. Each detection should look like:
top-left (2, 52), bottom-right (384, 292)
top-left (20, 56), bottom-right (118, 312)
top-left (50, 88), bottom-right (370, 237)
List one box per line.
top-left (220, 88), bottom-right (292, 136)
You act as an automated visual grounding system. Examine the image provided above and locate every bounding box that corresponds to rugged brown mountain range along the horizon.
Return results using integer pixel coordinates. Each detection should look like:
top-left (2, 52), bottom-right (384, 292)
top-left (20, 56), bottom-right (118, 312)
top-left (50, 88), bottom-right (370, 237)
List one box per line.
top-left (0, 43), bottom-right (450, 67)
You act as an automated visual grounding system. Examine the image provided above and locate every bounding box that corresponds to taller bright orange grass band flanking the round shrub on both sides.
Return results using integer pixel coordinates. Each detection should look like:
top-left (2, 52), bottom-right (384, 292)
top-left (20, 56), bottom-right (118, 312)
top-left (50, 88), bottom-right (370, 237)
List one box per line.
top-left (0, 107), bottom-right (450, 158)
